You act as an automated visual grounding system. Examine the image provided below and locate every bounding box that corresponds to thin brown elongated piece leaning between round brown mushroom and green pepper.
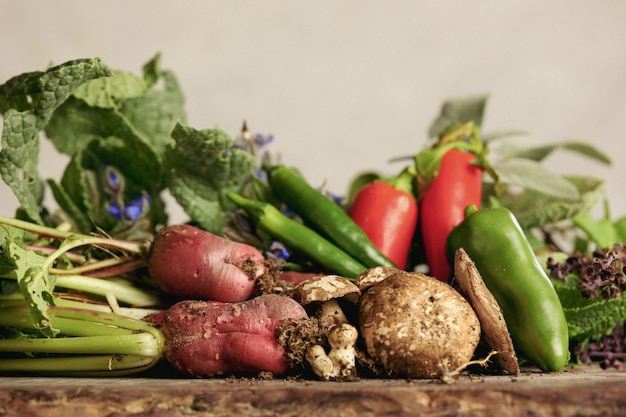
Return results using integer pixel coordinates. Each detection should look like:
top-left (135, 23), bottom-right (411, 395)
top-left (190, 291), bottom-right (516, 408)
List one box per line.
top-left (454, 248), bottom-right (520, 375)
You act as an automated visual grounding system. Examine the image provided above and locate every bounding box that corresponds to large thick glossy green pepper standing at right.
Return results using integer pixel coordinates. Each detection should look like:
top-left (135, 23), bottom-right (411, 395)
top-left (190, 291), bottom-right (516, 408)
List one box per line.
top-left (447, 205), bottom-right (569, 372)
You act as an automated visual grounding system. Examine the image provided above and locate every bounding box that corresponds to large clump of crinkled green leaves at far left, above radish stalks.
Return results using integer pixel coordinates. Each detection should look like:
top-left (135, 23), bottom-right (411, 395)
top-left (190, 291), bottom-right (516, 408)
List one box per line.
top-left (0, 54), bottom-right (185, 238)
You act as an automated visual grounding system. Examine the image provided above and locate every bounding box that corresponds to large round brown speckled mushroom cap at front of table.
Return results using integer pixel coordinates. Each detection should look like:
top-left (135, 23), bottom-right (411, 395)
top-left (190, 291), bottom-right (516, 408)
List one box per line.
top-left (359, 272), bottom-right (481, 378)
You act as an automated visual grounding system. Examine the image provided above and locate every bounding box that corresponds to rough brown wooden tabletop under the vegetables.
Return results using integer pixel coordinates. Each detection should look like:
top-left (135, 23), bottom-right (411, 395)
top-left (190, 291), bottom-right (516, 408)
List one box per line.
top-left (0, 367), bottom-right (626, 417)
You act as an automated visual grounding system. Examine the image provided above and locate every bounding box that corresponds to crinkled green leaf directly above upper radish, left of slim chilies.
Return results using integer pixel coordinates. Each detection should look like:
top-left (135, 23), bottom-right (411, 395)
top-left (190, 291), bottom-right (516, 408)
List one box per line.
top-left (165, 123), bottom-right (256, 234)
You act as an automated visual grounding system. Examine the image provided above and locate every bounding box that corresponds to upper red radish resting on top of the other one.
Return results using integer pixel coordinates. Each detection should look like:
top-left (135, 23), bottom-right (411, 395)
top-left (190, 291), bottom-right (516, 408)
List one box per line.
top-left (148, 225), bottom-right (267, 303)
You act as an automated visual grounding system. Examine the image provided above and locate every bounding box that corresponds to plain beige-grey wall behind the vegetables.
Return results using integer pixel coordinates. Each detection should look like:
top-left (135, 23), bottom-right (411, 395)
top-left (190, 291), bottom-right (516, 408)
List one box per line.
top-left (0, 0), bottom-right (626, 220)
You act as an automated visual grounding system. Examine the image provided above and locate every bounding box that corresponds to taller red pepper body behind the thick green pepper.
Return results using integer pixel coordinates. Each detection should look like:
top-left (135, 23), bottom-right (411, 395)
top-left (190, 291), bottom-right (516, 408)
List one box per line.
top-left (419, 148), bottom-right (483, 282)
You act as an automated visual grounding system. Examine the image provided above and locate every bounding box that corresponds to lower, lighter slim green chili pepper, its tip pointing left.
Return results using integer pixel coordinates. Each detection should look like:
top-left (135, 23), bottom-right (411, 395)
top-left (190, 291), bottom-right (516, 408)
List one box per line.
top-left (227, 193), bottom-right (367, 280)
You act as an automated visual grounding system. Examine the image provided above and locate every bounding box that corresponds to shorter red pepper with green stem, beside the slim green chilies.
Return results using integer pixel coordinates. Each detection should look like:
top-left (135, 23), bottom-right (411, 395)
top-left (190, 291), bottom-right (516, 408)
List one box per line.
top-left (348, 166), bottom-right (418, 269)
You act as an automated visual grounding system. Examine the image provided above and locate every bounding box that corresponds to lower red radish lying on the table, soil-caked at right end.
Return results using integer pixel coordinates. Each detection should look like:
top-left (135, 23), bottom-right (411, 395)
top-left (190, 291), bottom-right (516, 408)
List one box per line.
top-left (163, 294), bottom-right (307, 377)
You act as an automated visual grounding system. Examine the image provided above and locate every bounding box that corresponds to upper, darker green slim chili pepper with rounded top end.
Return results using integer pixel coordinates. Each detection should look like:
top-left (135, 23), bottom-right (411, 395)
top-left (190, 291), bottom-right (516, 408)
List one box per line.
top-left (268, 165), bottom-right (396, 268)
